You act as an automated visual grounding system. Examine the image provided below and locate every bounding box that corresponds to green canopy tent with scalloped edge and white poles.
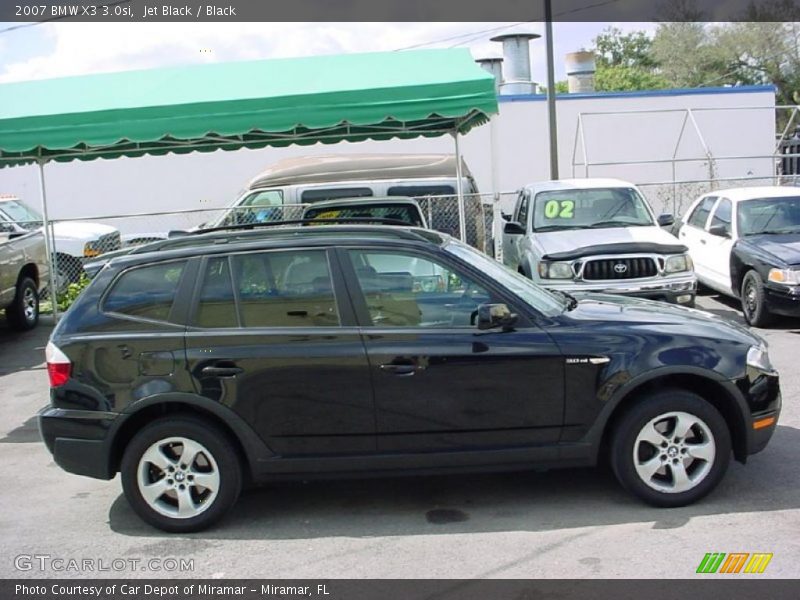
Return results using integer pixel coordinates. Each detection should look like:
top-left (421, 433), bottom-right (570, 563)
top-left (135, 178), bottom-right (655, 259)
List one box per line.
top-left (0, 49), bottom-right (497, 316)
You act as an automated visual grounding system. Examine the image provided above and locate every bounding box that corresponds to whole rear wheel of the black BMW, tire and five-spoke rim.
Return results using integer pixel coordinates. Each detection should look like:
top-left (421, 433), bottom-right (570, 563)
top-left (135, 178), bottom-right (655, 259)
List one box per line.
top-left (120, 416), bottom-right (242, 533)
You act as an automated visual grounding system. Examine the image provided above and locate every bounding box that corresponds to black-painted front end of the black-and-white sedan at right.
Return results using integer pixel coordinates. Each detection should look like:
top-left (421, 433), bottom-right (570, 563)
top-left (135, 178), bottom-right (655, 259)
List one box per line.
top-left (731, 233), bottom-right (800, 317)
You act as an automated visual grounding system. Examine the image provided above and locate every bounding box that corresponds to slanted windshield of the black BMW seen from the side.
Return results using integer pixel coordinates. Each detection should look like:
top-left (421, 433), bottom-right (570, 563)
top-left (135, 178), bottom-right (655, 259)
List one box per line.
top-left (444, 240), bottom-right (568, 317)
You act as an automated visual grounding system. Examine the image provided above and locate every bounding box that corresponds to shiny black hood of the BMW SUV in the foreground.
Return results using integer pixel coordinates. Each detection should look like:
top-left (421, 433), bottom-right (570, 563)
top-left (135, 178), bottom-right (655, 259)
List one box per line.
top-left (566, 293), bottom-right (763, 345)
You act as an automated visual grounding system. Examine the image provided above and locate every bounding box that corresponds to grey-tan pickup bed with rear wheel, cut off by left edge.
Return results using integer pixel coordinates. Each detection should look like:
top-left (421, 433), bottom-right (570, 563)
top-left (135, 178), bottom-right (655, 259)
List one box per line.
top-left (0, 223), bottom-right (49, 331)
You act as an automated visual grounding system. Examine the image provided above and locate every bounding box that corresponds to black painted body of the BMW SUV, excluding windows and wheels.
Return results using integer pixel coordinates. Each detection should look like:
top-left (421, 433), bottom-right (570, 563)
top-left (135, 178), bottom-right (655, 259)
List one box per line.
top-left (40, 226), bottom-right (780, 480)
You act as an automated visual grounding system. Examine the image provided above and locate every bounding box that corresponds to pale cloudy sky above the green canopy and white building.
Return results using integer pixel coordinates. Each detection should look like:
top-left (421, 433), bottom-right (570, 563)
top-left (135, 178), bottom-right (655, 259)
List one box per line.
top-left (0, 22), bottom-right (656, 83)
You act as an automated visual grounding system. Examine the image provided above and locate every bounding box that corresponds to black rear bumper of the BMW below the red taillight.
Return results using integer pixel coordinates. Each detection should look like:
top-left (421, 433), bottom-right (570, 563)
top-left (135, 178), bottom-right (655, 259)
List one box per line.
top-left (39, 406), bottom-right (120, 479)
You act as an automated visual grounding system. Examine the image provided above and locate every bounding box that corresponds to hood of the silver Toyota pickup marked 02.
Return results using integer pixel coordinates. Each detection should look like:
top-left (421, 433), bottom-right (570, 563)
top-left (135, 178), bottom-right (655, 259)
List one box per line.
top-left (533, 225), bottom-right (686, 257)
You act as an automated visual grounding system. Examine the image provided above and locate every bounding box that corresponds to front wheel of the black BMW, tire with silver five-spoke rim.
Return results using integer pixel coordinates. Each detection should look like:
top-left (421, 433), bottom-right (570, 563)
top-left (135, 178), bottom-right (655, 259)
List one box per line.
top-left (611, 389), bottom-right (731, 507)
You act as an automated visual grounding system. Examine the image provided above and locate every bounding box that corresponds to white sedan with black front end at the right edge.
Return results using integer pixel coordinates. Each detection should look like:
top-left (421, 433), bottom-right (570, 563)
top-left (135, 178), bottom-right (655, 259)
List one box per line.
top-left (678, 186), bottom-right (800, 327)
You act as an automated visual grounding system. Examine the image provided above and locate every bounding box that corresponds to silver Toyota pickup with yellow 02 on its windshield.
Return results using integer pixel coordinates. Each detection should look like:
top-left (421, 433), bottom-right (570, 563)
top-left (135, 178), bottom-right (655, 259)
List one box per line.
top-left (503, 179), bottom-right (697, 306)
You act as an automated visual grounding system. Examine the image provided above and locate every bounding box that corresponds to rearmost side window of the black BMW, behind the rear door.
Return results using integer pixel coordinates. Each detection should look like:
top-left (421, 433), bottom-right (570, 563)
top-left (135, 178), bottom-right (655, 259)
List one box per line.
top-left (102, 261), bottom-right (186, 322)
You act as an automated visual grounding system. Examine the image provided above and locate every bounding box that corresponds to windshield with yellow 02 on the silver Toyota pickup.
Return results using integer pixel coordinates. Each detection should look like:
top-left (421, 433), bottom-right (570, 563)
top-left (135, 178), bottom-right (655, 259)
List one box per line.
top-left (533, 188), bottom-right (654, 231)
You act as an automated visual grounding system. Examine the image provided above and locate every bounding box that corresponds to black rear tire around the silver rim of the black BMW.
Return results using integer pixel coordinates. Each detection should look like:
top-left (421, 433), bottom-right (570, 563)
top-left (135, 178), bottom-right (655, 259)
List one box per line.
top-left (120, 416), bottom-right (242, 533)
